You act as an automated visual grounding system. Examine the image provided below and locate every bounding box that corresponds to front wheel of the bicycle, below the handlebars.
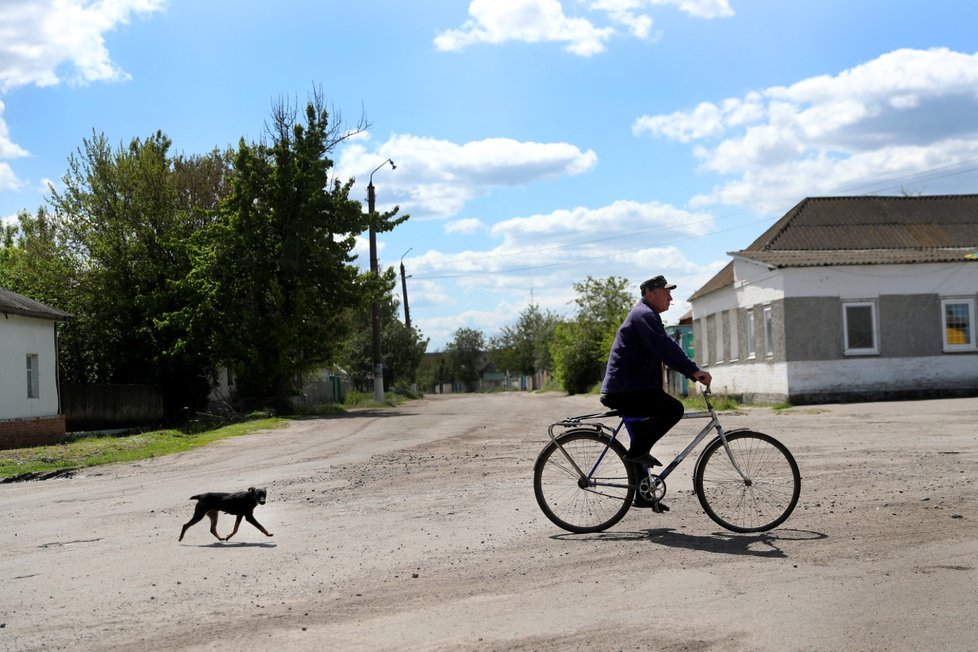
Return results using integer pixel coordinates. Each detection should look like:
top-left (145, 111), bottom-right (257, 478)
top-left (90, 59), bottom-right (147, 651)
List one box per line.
top-left (693, 431), bottom-right (801, 532)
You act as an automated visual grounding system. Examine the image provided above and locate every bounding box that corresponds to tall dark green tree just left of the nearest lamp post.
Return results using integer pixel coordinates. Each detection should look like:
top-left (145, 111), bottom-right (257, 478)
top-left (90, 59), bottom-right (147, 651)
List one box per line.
top-left (192, 93), bottom-right (407, 412)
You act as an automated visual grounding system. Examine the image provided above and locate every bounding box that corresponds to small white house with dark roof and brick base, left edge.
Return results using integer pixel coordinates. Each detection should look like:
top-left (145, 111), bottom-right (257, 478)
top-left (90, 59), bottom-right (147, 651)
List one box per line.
top-left (0, 288), bottom-right (70, 448)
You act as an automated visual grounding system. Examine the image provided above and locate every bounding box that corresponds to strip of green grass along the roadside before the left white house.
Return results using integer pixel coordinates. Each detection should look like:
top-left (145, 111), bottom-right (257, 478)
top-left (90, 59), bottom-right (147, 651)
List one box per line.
top-left (0, 418), bottom-right (288, 478)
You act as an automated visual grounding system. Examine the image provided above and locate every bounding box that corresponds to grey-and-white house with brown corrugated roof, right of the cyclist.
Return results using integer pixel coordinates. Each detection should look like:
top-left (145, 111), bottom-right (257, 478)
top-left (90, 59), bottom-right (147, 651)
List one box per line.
top-left (690, 195), bottom-right (978, 404)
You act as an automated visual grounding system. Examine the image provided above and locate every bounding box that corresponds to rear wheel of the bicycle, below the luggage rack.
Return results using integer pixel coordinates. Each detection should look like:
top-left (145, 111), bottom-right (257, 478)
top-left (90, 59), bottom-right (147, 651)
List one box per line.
top-left (533, 429), bottom-right (635, 534)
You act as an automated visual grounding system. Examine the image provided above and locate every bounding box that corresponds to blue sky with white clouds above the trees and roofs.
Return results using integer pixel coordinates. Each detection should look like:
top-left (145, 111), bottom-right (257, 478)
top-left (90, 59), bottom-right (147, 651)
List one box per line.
top-left (0, 0), bottom-right (978, 350)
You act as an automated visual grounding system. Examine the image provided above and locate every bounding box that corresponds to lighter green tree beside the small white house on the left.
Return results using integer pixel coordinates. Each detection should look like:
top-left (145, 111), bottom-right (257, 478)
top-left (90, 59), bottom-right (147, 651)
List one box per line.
top-left (49, 131), bottom-right (220, 418)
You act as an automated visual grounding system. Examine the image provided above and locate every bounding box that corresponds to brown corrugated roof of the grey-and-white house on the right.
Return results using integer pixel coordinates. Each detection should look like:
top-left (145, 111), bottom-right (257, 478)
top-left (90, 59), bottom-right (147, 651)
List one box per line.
top-left (691, 195), bottom-right (978, 298)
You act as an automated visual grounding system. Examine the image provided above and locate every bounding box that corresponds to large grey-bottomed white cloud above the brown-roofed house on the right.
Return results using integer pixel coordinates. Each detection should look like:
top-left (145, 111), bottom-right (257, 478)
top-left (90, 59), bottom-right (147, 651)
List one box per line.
top-left (633, 48), bottom-right (978, 210)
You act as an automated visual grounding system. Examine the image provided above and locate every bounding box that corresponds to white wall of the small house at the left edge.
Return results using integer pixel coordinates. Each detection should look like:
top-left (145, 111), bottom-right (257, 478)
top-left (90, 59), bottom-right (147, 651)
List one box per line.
top-left (0, 315), bottom-right (59, 419)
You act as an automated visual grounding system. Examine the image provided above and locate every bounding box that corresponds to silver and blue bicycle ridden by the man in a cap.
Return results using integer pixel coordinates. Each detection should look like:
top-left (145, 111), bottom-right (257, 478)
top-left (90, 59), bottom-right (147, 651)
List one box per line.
top-left (533, 388), bottom-right (801, 534)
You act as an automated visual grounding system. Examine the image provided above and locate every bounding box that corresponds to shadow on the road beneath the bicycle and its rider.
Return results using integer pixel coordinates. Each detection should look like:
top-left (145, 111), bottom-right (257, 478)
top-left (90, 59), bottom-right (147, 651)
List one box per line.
top-left (551, 528), bottom-right (828, 558)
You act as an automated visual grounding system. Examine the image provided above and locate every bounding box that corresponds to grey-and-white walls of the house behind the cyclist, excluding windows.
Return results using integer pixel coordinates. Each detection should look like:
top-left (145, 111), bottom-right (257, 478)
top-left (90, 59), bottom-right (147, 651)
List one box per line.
top-left (693, 261), bottom-right (978, 403)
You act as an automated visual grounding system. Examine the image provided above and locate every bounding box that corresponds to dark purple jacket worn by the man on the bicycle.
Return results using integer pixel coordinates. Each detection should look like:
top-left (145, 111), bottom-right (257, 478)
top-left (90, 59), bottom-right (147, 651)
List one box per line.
top-left (601, 300), bottom-right (700, 394)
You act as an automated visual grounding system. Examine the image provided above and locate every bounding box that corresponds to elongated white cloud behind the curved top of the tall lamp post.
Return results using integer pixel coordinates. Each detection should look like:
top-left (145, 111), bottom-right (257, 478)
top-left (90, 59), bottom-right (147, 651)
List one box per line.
top-left (336, 135), bottom-right (598, 219)
